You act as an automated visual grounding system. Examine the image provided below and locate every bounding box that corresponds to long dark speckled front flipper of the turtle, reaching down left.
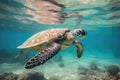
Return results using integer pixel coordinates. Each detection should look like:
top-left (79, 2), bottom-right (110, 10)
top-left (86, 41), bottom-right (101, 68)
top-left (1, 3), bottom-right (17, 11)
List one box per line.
top-left (25, 43), bottom-right (61, 69)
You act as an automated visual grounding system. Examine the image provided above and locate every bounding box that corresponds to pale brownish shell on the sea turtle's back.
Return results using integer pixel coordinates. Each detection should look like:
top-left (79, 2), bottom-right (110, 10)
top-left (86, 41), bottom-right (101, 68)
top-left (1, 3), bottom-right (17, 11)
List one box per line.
top-left (17, 28), bottom-right (69, 49)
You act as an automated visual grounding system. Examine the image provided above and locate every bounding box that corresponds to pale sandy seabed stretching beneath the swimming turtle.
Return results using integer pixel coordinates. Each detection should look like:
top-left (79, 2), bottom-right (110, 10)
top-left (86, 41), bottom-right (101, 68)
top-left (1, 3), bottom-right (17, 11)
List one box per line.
top-left (0, 53), bottom-right (120, 80)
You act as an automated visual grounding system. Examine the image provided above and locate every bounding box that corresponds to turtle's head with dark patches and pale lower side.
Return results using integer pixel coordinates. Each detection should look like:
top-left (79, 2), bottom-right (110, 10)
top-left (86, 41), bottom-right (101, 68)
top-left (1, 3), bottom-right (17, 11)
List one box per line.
top-left (71, 29), bottom-right (87, 40)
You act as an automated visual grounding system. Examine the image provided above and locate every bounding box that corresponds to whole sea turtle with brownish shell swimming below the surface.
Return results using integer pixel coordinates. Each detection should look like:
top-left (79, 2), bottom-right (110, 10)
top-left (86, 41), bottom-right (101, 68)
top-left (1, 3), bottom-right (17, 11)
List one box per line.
top-left (17, 28), bottom-right (86, 69)
